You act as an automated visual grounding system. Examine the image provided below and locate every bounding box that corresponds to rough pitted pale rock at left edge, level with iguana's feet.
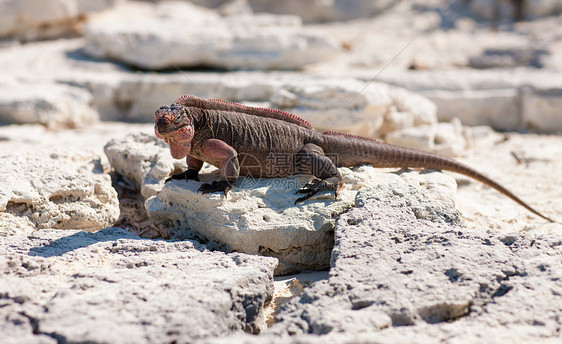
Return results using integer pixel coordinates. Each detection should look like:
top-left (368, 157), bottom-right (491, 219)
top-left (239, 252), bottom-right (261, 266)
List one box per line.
top-left (0, 150), bottom-right (119, 236)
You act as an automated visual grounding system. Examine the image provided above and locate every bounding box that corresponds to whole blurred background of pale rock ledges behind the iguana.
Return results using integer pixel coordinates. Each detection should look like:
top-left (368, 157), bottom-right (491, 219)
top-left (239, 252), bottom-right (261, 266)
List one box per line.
top-left (0, 0), bottom-right (562, 133)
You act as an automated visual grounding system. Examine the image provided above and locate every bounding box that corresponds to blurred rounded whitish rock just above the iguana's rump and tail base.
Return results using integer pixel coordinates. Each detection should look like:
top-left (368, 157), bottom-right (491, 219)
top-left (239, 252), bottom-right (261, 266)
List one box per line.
top-left (271, 78), bottom-right (437, 138)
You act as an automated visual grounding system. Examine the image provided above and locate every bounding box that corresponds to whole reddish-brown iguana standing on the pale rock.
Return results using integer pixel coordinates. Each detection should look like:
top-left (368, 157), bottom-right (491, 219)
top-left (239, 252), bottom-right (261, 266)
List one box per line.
top-left (154, 96), bottom-right (554, 222)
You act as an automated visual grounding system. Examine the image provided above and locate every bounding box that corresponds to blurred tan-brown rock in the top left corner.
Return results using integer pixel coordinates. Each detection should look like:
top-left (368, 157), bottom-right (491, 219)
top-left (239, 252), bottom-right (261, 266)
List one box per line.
top-left (0, 0), bottom-right (117, 41)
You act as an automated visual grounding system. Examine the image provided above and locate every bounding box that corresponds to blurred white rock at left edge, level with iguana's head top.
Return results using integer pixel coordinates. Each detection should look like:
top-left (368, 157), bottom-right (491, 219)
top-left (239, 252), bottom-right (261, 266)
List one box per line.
top-left (0, 82), bottom-right (99, 129)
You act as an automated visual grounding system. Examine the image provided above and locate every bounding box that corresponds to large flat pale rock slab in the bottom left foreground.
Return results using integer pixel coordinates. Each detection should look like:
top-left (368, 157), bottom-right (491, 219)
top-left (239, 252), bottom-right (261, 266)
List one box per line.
top-left (0, 228), bottom-right (277, 343)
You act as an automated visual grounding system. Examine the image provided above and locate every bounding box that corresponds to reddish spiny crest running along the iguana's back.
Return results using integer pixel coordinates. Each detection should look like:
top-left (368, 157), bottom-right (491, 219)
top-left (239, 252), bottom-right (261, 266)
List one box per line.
top-left (176, 95), bottom-right (314, 130)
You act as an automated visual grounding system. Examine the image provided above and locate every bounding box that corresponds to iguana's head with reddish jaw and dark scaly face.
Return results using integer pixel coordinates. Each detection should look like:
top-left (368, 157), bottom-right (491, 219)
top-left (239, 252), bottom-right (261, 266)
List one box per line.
top-left (154, 104), bottom-right (194, 159)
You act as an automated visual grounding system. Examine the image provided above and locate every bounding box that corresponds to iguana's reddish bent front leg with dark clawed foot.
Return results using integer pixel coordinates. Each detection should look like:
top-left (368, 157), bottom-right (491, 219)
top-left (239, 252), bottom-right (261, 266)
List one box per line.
top-left (197, 139), bottom-right (240, 196)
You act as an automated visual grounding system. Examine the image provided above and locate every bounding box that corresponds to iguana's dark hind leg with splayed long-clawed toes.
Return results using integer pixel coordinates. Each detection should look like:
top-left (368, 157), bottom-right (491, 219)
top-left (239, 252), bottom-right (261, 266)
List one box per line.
top-left (295, 143), bottom-right (343, 204)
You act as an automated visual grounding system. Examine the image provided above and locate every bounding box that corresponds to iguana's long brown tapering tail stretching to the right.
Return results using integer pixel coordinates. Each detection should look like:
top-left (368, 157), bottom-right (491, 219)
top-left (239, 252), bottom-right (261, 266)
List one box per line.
top-left (323, 132), bottom-right (555, 222)
